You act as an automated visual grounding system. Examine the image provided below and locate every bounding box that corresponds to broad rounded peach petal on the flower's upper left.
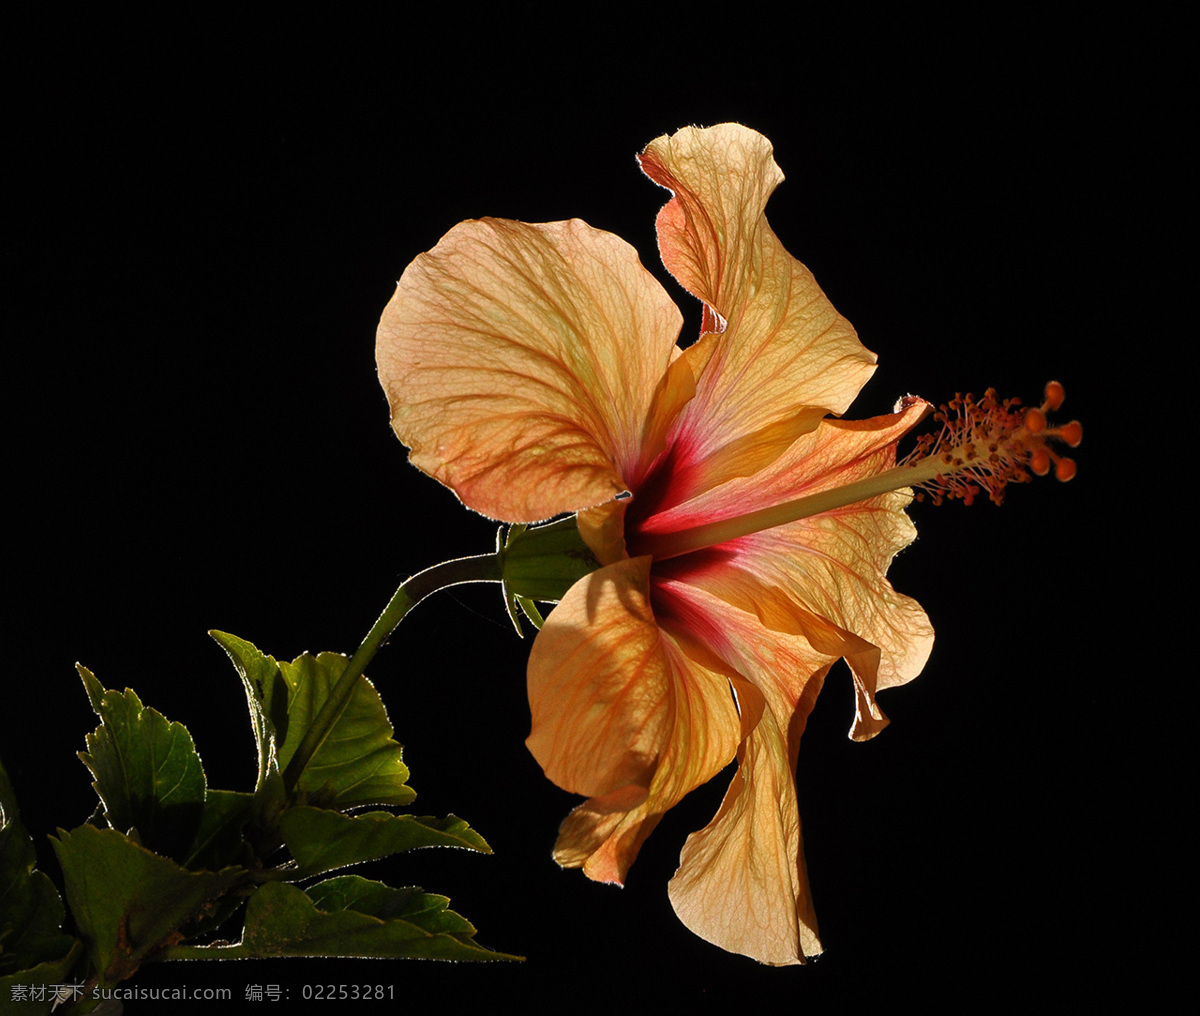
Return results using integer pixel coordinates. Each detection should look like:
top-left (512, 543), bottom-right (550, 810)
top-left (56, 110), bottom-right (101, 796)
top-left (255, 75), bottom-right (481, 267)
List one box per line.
top-left (377, 220), bottom-right (680, 522)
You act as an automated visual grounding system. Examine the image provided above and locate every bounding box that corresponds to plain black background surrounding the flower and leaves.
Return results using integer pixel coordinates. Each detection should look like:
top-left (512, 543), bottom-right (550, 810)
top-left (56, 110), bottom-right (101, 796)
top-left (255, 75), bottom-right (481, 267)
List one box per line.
top-left (7, 4), bottom-right (1180, 1012)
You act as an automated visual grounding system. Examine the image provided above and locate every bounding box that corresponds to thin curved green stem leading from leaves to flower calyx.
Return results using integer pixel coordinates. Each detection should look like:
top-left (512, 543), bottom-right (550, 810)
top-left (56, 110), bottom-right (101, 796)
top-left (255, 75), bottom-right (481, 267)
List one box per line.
top-left (283, 553), bottom-right (504, 792)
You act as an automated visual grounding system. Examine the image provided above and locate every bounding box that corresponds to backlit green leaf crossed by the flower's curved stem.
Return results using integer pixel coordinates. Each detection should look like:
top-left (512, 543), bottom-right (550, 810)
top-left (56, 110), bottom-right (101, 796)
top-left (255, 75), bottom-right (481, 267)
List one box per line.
top-left (211, 632), bottom-right (416, 810)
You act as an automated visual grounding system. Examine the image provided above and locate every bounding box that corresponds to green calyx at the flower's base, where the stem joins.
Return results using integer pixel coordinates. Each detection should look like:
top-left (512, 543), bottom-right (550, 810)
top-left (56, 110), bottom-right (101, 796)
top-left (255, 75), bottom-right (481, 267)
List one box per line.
top-left (496, 515), bottom-right (600, 632)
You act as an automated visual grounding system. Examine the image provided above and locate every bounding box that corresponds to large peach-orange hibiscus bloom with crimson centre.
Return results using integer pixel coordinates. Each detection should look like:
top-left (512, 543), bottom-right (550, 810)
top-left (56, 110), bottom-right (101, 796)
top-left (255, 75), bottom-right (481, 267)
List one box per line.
top-left (378, 124), bottom-right (1080, 964)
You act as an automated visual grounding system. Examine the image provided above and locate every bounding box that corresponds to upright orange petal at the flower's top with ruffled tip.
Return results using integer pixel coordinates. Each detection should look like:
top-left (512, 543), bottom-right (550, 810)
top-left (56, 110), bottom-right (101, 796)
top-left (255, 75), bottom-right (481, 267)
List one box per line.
top-left (641, 124), bottom-right (875, 492)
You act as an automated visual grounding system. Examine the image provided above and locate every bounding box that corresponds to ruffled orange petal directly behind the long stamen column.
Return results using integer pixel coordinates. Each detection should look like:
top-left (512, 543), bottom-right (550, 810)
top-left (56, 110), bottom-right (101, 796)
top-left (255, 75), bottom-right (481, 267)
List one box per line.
top-left (653, 404), bottom-right (934, 740)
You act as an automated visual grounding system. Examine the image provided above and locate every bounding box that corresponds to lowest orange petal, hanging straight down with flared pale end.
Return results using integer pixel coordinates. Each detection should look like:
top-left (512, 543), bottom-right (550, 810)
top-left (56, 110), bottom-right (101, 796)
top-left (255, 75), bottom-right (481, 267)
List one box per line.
top-left (654, 578), bottom-right (834, 964)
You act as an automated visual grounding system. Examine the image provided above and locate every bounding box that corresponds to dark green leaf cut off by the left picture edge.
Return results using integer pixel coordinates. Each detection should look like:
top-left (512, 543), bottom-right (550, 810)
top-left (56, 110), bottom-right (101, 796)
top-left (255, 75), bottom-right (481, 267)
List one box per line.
top-left (0, 763), bottom-right (74, 978)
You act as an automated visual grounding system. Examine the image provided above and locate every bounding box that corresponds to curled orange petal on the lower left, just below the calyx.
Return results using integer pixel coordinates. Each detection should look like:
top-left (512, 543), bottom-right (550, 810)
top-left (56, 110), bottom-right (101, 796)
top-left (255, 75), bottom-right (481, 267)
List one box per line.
top-left (527, 558), bottom-right (740, 883)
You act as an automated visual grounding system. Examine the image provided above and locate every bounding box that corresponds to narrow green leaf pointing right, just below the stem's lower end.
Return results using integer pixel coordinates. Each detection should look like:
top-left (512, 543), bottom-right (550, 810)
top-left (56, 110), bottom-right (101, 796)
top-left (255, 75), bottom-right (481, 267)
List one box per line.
top-left (280, 806), bottom-right (492, 878)
